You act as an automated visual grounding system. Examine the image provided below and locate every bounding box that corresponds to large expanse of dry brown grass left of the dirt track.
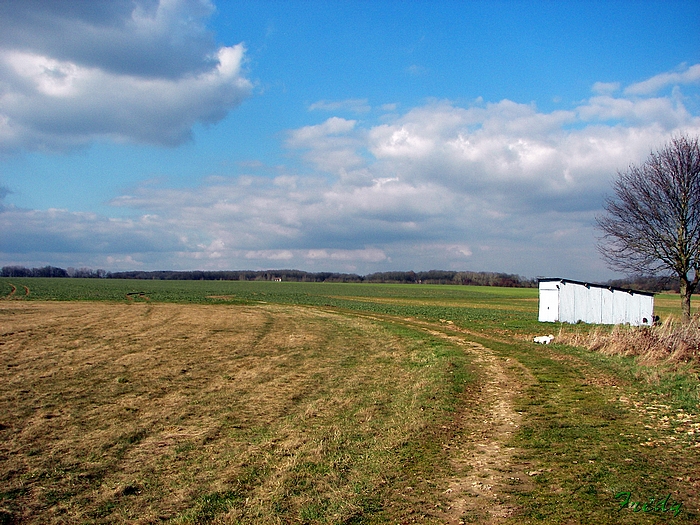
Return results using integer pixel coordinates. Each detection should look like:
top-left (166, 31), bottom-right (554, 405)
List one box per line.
top-left (0, 301), bottom-right (464, 524)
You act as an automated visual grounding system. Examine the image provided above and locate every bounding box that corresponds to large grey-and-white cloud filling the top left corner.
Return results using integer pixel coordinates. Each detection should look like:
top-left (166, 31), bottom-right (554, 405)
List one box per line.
top-left (0, 0), bottom-right (252, 151)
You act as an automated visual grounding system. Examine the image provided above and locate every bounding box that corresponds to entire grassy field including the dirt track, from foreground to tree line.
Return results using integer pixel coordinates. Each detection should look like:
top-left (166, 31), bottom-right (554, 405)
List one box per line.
top-left (0, 279), bottom-right (700, 524)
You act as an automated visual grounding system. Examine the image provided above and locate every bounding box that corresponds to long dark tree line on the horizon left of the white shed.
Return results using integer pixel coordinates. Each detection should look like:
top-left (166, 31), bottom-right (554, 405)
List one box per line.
top-left (0, 266), bottom-right (537, 288)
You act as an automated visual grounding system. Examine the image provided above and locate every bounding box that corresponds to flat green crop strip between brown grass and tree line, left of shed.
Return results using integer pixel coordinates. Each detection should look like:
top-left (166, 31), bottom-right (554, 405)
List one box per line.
top-left (0, 278), bottom-right (538, 330)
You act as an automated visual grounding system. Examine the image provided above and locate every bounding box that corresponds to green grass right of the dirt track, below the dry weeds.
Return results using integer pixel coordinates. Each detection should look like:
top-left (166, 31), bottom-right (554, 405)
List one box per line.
top-left (482, 341), bottom-right (700, 525)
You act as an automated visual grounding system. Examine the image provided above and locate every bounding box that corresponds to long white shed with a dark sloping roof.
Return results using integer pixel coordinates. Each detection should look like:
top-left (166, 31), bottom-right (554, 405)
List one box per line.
top-left (539, 279), bottom-right (654, 326)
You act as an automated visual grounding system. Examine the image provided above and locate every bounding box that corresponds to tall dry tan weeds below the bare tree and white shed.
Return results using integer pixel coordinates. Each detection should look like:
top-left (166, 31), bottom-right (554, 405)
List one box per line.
top-left (556, 316), bottom-right (700, 364)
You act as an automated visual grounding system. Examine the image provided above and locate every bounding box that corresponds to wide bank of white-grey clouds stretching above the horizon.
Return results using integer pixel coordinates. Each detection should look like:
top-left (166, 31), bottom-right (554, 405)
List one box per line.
top-left (0, 64), bottom-right (700, 279)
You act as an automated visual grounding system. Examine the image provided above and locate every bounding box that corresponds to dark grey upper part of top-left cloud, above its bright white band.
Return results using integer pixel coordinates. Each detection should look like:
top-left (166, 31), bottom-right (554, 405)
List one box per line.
top-left (0, 0), bottom-right (216, 79)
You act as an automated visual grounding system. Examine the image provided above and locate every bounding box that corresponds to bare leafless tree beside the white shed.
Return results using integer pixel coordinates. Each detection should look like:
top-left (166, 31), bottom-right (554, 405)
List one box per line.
top-left (597, 136), bottom-right (700, 321)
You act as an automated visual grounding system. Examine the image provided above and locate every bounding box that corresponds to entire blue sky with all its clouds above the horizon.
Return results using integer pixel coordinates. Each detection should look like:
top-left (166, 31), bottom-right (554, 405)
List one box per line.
top-left (0, 0), bottom-right (700, 280)
